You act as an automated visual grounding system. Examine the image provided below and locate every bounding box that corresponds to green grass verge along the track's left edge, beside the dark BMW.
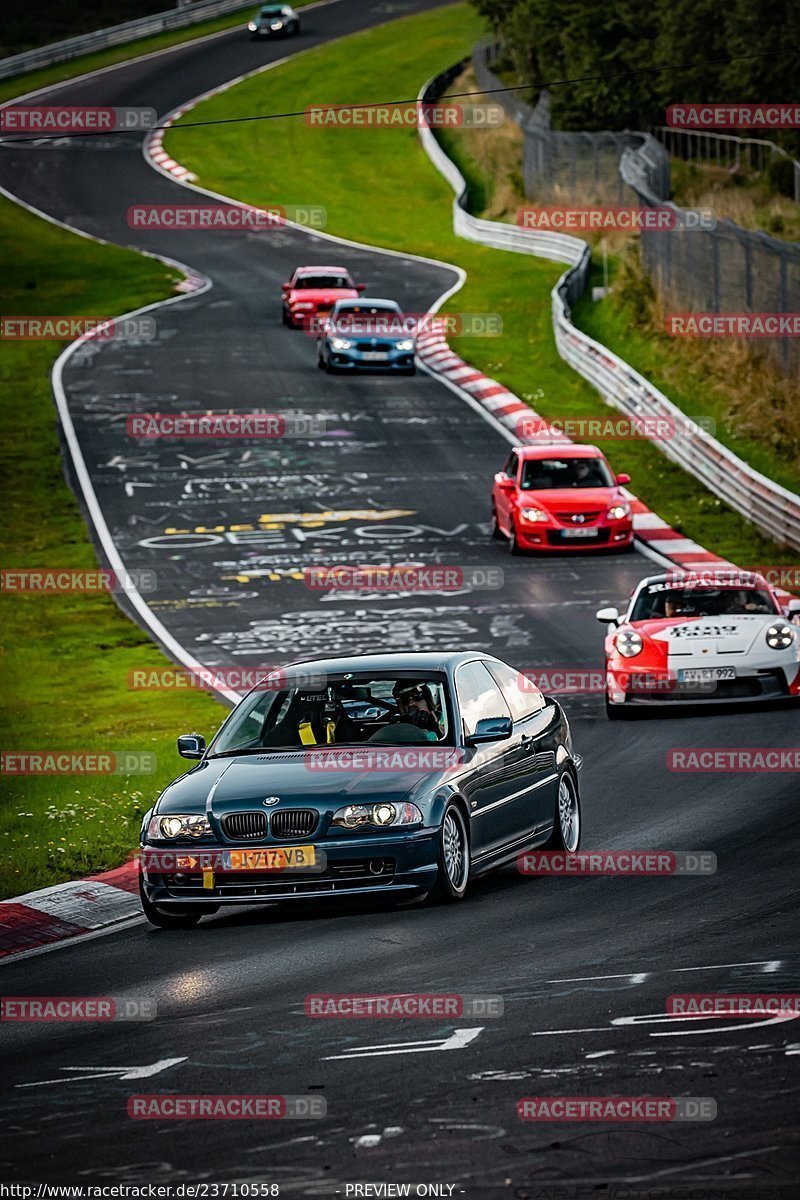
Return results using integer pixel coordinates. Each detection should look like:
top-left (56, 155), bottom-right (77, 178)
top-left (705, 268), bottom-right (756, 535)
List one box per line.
top-left (0, 199), bottom-right (224, 898)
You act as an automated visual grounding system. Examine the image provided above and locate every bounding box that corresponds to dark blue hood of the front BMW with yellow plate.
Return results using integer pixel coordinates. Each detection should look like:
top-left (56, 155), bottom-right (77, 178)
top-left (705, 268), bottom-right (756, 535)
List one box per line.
top-left (157, 745), bottom-right (458, 817)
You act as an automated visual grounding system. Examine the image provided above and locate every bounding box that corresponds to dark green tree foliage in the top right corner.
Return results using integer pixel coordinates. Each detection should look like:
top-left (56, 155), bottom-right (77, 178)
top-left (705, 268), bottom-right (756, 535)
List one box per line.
top-left (473, 0), bottom-right (800, 140)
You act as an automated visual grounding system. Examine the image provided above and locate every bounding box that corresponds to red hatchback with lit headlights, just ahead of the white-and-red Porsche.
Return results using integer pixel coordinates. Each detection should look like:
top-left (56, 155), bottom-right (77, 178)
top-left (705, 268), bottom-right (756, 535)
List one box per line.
top-left (492, 443), bottom-right (633, 554)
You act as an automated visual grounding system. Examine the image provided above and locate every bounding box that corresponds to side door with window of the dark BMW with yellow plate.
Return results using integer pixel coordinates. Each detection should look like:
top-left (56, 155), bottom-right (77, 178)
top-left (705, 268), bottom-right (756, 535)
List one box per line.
top-left (456, 659), bottom-right (523, 865)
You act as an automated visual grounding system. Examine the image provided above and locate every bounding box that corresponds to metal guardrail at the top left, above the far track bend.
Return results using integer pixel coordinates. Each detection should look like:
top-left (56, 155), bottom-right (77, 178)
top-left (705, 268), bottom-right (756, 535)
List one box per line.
top-left (0, 0), bottom-right (254, 79)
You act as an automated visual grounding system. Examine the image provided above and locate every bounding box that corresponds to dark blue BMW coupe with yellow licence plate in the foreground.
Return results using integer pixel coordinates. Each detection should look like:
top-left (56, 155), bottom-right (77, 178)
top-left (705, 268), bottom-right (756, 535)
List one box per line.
top-left (139, 653), bottom-right (581, 928)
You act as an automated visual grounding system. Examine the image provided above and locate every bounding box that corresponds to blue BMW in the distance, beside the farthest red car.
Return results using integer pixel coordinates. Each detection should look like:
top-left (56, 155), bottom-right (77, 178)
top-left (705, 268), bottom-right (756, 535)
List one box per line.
top-left (317, 298), bottom-right (416, 374)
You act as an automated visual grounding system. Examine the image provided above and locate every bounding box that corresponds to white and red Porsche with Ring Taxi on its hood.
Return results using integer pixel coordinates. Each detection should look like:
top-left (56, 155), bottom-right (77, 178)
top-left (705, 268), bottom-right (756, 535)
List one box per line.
top-left (597, 570), bottom-right (800, 720)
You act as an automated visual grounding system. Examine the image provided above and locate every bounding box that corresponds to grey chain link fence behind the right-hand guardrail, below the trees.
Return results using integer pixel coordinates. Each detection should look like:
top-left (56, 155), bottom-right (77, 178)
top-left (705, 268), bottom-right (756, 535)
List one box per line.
top-left (473, 43), bottom-right (800, 378)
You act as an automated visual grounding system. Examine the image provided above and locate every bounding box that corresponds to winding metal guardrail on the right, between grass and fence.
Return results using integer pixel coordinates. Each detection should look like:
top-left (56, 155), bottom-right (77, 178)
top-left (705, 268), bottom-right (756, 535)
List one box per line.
top-left (419, 61), bottom-right (800, 550)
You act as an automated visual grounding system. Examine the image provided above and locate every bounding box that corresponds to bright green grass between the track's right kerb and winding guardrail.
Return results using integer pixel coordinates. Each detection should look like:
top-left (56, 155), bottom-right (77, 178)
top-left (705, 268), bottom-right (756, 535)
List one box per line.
top-left (167, 5), bottom-right (792, 564)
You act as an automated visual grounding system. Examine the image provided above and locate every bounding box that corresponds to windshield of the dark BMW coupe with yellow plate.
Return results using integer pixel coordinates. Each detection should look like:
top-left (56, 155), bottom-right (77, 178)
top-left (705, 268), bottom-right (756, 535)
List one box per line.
top-left (209, 672), bottom-right (453, 757)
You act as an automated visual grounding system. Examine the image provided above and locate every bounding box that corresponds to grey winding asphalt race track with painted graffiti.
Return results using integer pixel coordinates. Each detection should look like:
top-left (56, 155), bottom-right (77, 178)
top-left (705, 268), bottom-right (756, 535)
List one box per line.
top-left (0, 0), bottom-right (800, 1200)
